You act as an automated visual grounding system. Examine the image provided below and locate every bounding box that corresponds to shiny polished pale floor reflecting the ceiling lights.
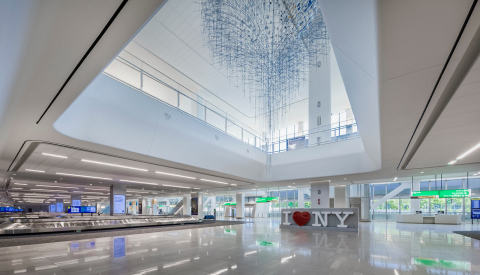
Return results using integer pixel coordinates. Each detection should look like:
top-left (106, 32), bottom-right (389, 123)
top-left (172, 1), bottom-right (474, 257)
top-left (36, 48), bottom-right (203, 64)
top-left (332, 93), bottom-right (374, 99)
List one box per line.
top-left (0, 219), bottom-right (480, 275)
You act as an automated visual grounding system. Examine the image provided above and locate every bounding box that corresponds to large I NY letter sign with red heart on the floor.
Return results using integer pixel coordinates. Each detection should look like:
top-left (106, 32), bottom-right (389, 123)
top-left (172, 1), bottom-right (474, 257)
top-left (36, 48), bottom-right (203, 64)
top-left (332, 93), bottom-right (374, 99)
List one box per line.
top-left (280, 208), bottom-right (359, 231)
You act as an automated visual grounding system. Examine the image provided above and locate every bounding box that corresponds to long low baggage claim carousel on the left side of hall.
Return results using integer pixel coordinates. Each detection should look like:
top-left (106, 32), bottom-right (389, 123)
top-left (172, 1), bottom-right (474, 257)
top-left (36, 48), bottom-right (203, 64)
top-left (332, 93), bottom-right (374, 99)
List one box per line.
top-left (0, 216), bottom-right (202, 236)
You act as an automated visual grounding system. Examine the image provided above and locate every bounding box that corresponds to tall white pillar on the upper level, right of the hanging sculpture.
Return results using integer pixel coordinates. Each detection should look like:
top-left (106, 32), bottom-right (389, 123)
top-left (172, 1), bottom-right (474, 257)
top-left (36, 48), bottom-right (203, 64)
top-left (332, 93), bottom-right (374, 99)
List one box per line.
top-left (308, 53), bottom-right (333, 144)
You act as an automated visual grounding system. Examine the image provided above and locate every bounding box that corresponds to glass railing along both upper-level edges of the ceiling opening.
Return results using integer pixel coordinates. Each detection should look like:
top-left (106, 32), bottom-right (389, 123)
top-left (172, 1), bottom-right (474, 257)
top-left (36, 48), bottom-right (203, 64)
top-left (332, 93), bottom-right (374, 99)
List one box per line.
top-left (104, 56), bottom-right (359, 153)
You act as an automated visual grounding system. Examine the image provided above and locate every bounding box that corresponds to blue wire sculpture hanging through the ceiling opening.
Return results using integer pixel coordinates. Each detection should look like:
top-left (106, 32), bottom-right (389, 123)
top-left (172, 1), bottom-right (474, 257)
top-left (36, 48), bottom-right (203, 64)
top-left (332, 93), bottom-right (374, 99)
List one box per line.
top-left (201, 0), bottom-right (330, 134)
